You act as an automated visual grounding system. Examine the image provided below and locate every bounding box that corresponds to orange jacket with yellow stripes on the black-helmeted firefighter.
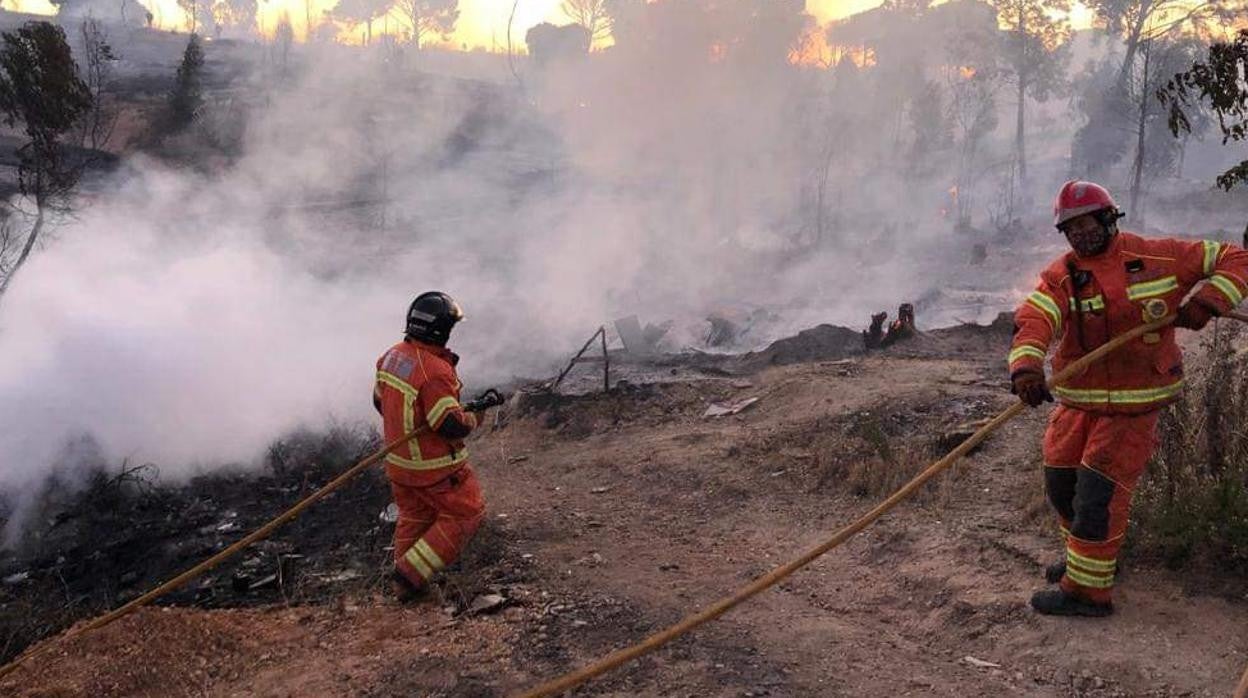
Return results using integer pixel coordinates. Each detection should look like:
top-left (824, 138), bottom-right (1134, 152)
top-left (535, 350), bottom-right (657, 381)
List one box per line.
top-left (373, 341), bottom-right (477, 487)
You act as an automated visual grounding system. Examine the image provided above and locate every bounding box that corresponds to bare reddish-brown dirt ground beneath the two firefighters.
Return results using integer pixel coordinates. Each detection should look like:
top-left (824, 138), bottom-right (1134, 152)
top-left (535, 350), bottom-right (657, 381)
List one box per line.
top-left (0, 323), bottom-right (1248, 697)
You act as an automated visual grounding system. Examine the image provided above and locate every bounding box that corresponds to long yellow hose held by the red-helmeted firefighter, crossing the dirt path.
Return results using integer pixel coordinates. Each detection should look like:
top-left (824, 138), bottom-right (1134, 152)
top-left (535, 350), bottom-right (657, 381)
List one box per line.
top-left (511, 315), bottom-right (1176, 698)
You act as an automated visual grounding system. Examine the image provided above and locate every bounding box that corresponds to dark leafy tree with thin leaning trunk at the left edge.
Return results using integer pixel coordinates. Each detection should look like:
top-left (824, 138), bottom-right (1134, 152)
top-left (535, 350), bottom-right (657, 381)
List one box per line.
top-left (0, 21), bottom-right (92, 296)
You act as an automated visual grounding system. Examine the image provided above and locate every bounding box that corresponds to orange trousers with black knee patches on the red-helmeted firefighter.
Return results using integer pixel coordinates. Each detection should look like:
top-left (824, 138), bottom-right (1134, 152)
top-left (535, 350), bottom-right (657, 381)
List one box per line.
top-left (1045, 406), bottom-right (1158, 603)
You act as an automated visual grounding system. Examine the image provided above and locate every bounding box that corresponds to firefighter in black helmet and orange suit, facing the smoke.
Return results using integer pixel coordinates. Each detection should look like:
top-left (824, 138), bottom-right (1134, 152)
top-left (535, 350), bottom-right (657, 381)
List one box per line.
top-left (373, 291), bottom-right (500, 602)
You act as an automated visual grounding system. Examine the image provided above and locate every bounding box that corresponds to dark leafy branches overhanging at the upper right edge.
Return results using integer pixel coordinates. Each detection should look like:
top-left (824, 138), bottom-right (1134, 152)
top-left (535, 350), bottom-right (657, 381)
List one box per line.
top-left (1157, 29), bottom-right (1248, 191)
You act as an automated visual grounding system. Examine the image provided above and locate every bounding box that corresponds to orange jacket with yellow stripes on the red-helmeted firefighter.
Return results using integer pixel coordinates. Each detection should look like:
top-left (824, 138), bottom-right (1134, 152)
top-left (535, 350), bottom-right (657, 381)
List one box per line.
top-left (1010, 232), bottom-right (1248, 415)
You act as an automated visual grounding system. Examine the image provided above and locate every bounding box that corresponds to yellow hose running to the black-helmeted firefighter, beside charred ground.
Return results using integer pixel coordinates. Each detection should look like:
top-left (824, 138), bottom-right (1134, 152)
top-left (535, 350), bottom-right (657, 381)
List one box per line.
top-left (0, 425), bottom-right (427, 678)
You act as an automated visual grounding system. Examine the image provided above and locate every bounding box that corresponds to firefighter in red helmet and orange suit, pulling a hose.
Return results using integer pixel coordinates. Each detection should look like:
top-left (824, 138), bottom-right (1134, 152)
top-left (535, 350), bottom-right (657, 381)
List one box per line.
top-left (1010, 181), bottom-right (1248, 616)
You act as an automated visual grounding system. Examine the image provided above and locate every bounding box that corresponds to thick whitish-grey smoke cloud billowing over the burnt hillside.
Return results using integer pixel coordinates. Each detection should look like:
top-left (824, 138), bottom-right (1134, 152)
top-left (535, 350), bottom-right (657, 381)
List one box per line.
top-left (9, 2), bottom-right (1238, 534)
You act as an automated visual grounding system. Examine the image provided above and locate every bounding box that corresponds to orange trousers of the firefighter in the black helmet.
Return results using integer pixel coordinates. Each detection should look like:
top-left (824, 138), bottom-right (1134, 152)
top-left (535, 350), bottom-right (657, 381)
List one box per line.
top-left (391, 465), bottom-right (485, 587)
